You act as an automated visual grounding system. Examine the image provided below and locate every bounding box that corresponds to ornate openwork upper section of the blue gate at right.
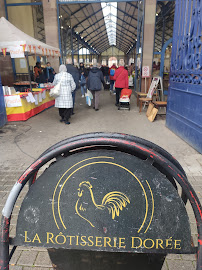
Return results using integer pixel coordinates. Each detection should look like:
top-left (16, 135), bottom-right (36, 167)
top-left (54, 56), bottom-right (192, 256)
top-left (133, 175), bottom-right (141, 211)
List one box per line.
top-left (170, 0), bottom-right (202, 84)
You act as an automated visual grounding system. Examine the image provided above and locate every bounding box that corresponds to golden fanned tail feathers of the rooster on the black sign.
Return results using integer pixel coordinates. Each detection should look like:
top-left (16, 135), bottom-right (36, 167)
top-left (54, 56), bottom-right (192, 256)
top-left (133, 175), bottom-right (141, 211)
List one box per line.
top-left (102, 191), bottom-right (130, 219)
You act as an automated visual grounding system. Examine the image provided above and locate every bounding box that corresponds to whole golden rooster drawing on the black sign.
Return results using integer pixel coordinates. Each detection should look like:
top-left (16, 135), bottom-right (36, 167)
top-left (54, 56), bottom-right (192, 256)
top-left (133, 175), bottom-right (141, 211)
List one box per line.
top-left (75, 181), bottom-right (130, 227)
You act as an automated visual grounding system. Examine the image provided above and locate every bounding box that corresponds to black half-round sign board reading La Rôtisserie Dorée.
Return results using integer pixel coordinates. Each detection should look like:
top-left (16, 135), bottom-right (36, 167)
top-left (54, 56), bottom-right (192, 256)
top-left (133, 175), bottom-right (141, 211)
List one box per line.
top-left (14, 150), bottom-right (192, 254)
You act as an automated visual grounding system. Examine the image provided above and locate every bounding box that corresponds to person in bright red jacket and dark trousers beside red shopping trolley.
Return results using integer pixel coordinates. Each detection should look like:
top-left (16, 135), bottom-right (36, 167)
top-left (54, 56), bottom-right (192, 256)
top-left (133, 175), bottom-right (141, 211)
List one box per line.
top-left (114, 60), bottom-right (128, 106)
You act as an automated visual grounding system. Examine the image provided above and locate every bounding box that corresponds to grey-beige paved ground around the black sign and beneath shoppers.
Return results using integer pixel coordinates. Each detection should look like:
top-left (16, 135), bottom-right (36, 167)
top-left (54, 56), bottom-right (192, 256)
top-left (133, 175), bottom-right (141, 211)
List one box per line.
top-left (0, 93), bottom-right (202, 270)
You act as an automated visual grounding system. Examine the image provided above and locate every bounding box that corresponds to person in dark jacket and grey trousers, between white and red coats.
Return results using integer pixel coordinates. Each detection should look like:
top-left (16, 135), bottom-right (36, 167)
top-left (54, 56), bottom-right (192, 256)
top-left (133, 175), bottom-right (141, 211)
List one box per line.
top-left (87, 64), bottom-right (104, 111)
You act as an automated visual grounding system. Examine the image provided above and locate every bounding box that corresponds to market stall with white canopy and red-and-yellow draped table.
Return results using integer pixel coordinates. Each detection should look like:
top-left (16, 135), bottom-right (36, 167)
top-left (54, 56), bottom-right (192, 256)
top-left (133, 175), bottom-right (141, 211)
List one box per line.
top-left (0, 17), bottom-right (60, 121)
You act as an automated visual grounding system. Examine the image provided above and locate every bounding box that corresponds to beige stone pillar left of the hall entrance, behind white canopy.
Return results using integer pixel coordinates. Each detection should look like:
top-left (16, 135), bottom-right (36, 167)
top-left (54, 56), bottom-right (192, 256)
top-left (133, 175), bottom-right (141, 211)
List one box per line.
top-left (43, 0), bottom-right (59, 72)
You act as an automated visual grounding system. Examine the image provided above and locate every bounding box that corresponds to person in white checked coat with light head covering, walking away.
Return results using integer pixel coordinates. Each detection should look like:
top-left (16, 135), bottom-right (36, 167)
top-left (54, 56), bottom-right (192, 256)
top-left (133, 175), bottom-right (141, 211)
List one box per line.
top-left (53, 65), bottom-right (76, 125)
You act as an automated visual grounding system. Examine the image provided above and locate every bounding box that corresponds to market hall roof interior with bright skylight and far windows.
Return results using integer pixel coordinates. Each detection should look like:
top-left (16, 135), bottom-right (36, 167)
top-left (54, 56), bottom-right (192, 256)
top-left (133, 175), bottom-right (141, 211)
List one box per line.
top-left (55, 1), bottom-right (144, 90)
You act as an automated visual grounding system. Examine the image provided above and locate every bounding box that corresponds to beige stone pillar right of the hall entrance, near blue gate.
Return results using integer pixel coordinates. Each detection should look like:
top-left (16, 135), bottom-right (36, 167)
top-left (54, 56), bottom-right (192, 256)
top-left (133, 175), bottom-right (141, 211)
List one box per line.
top-left (141, 0), bottom-right (157, 92)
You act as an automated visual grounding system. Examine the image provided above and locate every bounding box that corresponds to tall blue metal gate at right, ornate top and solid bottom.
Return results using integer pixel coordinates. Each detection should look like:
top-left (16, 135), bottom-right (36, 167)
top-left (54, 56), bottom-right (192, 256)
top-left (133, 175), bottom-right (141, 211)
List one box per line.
top-left (166, 0), bottom-right (202, 153)
